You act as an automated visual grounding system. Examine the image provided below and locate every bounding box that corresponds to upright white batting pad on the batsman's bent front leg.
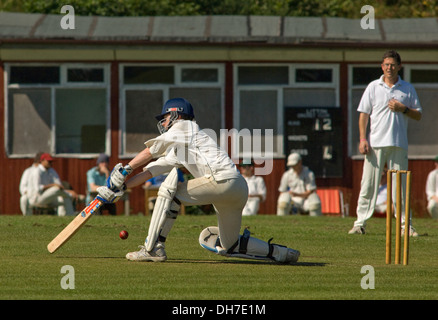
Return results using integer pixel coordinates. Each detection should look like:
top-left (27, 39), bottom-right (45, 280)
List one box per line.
top-left (145, 168), bottom-right (178, 251)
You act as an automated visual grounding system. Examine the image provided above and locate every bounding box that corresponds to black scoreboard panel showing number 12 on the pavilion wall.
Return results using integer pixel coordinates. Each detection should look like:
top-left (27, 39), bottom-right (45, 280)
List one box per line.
top-left (284, 107), bottom-right (343, 178)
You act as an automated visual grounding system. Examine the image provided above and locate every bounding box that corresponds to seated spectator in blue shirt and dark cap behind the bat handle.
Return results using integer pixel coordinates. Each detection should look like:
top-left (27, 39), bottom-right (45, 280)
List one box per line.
top-left (86, 153), bottom-right (117, 216)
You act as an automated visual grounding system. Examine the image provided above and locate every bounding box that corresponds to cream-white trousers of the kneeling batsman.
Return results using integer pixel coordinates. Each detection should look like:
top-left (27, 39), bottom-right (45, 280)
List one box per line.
top-left (175, 176), bottom-right (248, 250)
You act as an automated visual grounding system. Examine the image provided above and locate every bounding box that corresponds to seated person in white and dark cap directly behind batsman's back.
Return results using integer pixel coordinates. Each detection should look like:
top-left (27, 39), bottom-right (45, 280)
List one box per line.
top-left (239, 161), bottom-right (266, 216)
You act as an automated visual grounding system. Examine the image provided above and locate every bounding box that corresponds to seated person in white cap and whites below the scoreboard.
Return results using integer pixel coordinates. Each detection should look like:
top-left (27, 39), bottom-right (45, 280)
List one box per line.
top-left (277, 153), bottom-right (322, 217)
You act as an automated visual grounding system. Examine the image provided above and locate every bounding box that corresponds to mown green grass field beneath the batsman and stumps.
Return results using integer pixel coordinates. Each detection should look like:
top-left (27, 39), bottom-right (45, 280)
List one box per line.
top-left (0, 215), bottom-right (438, 300)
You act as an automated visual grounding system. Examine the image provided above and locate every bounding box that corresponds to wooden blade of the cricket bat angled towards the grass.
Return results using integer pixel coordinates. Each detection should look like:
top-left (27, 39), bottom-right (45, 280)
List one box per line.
top-left (47, 197), bottom-right (103, 253)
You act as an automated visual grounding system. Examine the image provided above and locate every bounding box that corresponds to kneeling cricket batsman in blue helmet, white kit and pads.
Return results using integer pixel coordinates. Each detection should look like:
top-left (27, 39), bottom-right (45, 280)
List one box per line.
top-left (98, 98), bottom-right (300, 264)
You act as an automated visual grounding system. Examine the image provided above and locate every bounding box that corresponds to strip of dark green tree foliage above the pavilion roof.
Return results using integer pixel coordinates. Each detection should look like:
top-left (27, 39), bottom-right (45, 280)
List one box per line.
top-left (0, 0), bottom-right (438, 18)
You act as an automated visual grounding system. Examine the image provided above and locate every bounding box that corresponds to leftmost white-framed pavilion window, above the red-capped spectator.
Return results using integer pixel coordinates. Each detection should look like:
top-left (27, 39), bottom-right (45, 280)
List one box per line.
top-left (5, 64), bottom-right (110, 156)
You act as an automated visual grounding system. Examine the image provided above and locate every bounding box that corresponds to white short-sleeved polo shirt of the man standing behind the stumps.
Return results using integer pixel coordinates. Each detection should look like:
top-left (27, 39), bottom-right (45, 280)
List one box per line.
top-left (357, 76), bottom-right (422, 150)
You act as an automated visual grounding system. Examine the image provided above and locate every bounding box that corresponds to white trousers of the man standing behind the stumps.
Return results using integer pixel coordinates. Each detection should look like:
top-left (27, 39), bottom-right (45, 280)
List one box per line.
top-left (354, 147), bottom-right (408, 227)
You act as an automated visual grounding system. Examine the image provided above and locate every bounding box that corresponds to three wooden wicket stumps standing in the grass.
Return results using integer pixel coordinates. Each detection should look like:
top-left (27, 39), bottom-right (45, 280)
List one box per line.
top-left (386, 170), bottom-right (411, 265)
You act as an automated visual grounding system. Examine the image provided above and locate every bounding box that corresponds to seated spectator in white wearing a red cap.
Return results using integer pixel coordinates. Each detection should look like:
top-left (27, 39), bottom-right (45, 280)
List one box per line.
top-left (29, 153), bottom-right (78, 216)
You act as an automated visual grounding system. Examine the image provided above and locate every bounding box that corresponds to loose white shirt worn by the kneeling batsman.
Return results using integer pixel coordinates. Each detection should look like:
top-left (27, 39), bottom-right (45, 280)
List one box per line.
top-left (145, 120), bottom-right (240, 181)
